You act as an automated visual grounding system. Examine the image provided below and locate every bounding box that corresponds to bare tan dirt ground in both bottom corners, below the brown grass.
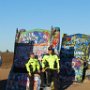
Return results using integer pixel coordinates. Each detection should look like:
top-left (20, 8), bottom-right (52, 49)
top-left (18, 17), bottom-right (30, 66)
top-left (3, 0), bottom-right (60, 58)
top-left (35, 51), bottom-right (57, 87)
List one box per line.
top-left (0, 68), bottom-right (90, 90)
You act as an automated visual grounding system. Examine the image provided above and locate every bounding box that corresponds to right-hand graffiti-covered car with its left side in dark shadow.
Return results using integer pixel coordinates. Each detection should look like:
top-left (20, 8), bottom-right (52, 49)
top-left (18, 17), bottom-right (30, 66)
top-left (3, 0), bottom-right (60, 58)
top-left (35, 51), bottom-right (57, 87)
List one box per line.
top-left (60, 34), bottom-right (90, 82)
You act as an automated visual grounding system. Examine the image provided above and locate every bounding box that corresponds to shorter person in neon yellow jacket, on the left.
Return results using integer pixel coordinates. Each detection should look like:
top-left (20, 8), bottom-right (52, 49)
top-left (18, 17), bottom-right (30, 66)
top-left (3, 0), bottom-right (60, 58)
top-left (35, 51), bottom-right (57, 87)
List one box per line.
top-left (25, 53), bottom-right (40, 90)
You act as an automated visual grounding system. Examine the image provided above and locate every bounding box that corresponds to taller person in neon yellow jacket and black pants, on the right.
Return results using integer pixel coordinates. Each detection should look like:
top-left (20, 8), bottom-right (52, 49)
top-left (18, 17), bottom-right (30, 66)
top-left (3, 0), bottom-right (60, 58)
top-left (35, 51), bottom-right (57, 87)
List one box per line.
top-left (42, 46), bottom-right (60, 90)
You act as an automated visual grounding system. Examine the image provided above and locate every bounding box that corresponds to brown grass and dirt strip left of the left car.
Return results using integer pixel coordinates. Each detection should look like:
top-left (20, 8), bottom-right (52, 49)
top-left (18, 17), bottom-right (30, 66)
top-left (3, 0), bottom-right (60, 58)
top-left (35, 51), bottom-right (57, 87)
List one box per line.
top-left (0, 52), bottom-right (13, 90)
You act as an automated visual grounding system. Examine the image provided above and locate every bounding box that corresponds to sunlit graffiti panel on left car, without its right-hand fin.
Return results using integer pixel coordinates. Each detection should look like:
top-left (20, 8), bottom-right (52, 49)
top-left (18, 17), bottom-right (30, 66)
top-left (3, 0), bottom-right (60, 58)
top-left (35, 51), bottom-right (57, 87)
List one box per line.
top-left (16, 29), bottom-right (50, 60)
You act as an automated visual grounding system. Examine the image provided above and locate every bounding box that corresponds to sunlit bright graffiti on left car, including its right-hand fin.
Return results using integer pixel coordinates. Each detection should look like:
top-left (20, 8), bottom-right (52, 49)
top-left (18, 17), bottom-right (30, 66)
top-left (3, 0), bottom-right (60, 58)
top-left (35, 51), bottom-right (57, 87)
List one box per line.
top-left (16, 27), bottom-right (60, 59)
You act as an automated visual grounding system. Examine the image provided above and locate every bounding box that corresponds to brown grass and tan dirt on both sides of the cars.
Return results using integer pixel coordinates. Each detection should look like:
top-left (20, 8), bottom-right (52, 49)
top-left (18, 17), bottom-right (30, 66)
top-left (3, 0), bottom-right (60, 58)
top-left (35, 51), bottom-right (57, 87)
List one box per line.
top-left (0, 52), bottom-right (90, 90)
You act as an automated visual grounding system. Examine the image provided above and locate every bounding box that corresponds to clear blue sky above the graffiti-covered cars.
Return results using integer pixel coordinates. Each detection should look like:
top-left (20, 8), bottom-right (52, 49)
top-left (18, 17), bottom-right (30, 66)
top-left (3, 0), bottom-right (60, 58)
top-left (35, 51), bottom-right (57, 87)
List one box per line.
top-left (0, 0), bottom-right (90, 51)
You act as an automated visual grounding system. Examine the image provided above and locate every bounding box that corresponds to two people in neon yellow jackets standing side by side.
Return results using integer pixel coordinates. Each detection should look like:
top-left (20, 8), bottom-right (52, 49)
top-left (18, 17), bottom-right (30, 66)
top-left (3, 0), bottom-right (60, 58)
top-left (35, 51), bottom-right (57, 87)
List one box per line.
top-left (25, 47), bottom-right (60, 90)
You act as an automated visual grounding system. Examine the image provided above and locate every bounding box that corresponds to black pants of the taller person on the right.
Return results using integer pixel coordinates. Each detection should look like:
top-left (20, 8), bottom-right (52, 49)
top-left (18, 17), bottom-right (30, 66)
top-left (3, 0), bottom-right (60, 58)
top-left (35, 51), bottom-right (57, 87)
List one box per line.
top-left (41, 69), bottom-right (59, 90)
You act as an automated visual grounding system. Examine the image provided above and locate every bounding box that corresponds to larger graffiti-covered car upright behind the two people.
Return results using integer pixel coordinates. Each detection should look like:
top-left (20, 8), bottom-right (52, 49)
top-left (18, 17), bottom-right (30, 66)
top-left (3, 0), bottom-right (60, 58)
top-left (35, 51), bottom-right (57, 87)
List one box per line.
top-left (6, 29), bottom-right (60, 90)
